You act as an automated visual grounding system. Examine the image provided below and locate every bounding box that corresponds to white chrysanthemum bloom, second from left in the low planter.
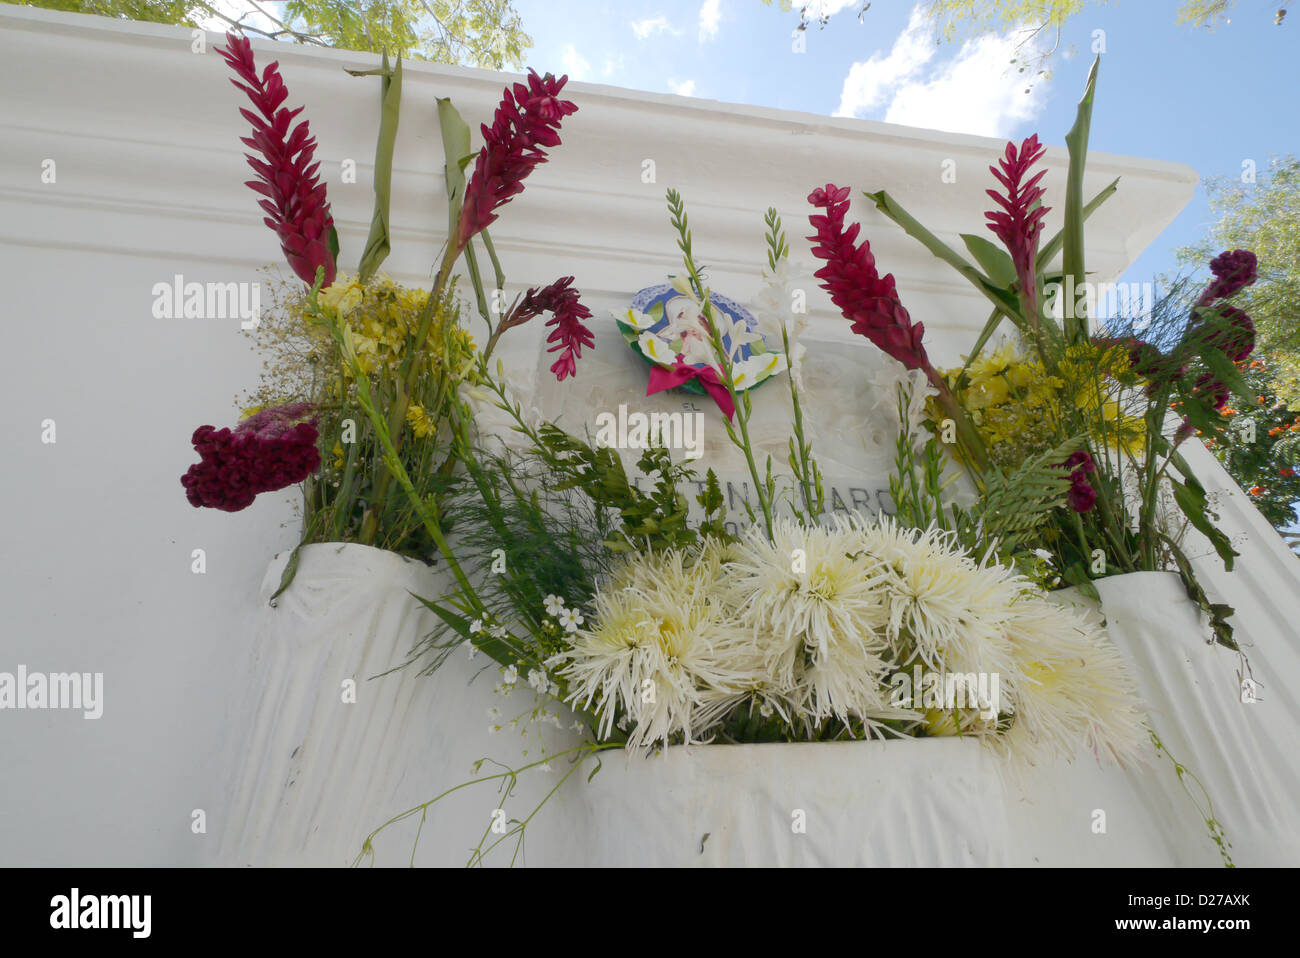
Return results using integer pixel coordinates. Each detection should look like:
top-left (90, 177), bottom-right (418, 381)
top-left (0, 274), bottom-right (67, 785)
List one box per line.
top-left (725, 517), bottom-right (889, 719)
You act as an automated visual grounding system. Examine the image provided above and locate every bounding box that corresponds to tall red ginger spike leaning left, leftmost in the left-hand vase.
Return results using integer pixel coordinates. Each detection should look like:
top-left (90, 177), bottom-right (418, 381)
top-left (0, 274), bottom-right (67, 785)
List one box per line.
top-left (217, 34), bottom-right (334, 289)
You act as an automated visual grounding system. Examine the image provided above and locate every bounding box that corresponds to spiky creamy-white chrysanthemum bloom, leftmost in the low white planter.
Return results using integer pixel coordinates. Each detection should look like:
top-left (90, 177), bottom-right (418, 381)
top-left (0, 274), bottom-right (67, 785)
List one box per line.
top-left (558, 551), bottom-right (763, 749)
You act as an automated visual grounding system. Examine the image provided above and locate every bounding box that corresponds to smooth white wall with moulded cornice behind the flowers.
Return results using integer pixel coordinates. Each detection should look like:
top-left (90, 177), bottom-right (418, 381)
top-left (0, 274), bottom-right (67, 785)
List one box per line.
top-left (0, 6), bottom-right (1295, 864)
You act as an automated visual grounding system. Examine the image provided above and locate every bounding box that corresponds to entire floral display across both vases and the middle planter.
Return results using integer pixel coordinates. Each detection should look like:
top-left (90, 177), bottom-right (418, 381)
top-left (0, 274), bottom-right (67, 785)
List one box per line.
top-left (183, 38), bottom-right (1253, 868)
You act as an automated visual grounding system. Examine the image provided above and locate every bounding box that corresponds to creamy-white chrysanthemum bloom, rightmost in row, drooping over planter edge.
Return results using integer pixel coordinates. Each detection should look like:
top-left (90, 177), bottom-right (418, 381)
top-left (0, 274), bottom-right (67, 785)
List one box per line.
top-left (997, 595), bottom-right (1151, 767)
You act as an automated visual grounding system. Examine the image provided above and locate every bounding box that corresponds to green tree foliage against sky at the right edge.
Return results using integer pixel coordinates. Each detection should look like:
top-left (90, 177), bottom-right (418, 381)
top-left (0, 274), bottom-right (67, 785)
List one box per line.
top-left (1178, 156), bottom-right (1300, 408)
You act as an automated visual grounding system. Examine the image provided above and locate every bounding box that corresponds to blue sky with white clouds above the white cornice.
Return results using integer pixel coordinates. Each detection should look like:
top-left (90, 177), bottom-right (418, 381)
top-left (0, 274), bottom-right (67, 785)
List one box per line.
top-left (515, 0), bottom-right (1300, 287)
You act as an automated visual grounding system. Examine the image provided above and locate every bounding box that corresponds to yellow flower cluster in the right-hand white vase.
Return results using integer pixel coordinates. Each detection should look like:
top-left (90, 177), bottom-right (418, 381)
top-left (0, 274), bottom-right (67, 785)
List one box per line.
top-left (928, 343), bottom-right (1143, 465)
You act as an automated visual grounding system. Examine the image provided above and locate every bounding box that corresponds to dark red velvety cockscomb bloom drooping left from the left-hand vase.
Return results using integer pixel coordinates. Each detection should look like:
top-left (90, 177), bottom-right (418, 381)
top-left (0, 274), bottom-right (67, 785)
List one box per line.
top-left (181, 403), bottom-right (321, 512)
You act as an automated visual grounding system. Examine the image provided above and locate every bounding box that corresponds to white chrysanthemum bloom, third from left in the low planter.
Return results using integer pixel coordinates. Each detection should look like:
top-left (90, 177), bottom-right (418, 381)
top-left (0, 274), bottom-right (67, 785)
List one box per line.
top-left (849, 516), bottom-right (1028, 673)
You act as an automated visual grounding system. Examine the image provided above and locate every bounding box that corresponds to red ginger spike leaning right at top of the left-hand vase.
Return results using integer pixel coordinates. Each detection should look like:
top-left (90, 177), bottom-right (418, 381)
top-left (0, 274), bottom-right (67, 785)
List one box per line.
top-left (456, 70), bottom-right (577, 250)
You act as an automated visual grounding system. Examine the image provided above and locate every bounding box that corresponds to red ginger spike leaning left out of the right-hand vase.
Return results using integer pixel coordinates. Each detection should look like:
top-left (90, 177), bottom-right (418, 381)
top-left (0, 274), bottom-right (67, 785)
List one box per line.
top-left (809, 183), bottom-right (931, 372)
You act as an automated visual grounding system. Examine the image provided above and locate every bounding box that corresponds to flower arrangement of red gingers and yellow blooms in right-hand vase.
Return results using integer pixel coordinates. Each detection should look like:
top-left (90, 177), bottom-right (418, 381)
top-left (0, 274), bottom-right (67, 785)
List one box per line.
top-left (842, 58), bottom-right (1256, 649)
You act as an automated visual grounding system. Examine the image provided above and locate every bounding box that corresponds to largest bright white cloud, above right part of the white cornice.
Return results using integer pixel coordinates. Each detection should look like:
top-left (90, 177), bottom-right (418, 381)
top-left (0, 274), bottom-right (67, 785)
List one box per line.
top-left (836, 6), bottom-right (1047, 138)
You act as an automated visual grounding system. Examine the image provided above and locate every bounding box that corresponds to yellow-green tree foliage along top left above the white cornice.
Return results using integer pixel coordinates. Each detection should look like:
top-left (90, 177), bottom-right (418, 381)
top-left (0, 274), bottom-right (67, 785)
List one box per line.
top-left (4, 0), bottom-right (533, 70)
